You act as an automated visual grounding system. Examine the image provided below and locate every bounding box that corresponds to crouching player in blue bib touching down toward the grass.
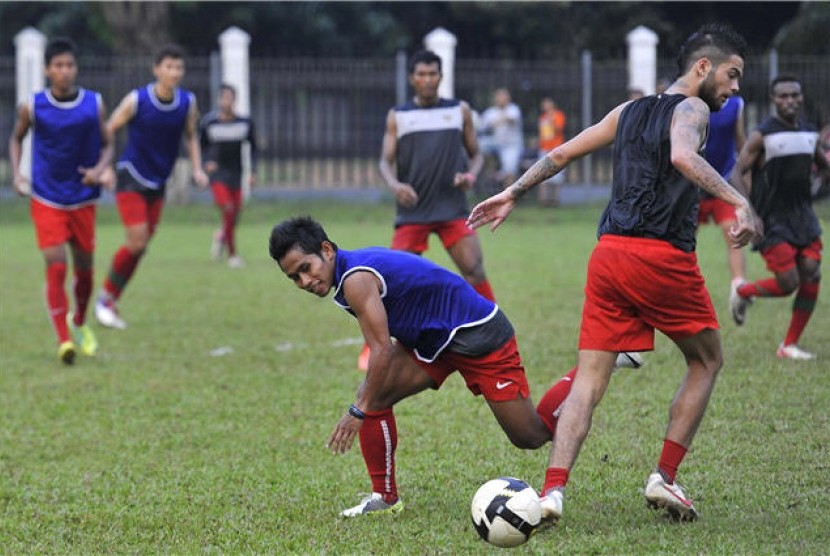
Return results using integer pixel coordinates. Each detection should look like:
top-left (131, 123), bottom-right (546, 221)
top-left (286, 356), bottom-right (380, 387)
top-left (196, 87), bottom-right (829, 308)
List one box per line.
top-left (270, 217), bottom-right (576, 517)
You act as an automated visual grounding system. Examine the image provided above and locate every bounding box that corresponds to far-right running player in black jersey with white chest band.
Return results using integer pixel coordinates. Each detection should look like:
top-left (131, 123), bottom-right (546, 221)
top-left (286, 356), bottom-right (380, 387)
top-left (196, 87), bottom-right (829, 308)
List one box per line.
top-left (730, 75), bottom-right (830, 360)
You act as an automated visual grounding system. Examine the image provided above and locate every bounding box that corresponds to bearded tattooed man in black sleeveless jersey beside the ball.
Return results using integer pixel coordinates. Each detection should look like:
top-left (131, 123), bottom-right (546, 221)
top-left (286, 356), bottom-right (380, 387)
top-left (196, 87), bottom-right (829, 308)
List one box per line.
top-left (468, 25), bottom-right (760, 520)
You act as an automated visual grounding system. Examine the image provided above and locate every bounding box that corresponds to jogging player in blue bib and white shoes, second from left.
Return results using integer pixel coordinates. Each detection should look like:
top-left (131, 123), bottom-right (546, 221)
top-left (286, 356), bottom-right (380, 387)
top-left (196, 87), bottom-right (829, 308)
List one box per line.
top-left (95, 45), bottom-right (208, 329)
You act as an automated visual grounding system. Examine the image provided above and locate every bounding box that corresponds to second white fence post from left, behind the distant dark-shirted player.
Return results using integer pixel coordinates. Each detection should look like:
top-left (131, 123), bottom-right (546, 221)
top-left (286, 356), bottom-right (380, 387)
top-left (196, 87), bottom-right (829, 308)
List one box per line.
top-left (219, 26), bottom-right (252, 200)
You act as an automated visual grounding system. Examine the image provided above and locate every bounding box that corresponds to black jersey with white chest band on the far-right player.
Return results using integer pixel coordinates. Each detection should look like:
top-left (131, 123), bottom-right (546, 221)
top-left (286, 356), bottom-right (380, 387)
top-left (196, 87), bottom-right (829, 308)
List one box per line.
top-left (750, 117), bottom-right (821, 250)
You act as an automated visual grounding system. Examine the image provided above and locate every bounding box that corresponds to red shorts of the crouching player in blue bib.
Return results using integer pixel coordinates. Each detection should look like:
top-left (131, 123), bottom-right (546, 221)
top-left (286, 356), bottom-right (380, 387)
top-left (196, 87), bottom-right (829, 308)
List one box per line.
top-left (409, 336), bottom-right (530, 402)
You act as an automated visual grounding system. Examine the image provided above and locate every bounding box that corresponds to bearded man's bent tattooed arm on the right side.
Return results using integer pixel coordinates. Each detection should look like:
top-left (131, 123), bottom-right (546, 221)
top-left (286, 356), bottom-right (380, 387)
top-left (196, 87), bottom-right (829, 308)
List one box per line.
top-left (669, 97), bottom-right (760, 246)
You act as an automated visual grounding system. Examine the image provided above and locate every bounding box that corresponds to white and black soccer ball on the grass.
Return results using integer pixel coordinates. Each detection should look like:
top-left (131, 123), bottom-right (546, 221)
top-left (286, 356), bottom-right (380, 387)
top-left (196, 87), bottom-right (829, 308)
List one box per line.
top-left (470, 477), bottom-right (542, 548)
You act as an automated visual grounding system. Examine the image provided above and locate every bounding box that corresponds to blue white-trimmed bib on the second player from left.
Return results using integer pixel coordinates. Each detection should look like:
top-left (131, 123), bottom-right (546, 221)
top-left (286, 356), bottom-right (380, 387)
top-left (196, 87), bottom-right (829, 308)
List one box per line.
top-left (116, 83), bottom-right (196, 189)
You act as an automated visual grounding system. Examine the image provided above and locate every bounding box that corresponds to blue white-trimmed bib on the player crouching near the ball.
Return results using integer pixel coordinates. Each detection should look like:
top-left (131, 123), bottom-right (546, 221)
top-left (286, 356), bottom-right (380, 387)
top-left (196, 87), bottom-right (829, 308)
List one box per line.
top-left (334, 247), bottom-right (498, 363)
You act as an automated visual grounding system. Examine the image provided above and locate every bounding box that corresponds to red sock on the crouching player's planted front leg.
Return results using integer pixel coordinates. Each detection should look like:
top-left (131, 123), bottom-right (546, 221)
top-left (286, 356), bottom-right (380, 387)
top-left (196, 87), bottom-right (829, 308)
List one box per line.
top-left (360, 407), bottom-right (398, 504)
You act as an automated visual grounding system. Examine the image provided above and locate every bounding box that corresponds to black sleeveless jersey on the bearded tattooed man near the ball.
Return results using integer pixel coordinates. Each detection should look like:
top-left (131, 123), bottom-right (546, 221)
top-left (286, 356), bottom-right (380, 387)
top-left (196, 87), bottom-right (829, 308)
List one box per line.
top-left (597, 95), bottom-right (700, 252)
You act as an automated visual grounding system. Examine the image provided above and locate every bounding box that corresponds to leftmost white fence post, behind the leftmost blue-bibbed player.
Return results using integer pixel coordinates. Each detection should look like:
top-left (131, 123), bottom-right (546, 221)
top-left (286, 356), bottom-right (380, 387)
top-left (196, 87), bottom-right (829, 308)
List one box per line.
top-left (14, 27), bottom-right (46, 194)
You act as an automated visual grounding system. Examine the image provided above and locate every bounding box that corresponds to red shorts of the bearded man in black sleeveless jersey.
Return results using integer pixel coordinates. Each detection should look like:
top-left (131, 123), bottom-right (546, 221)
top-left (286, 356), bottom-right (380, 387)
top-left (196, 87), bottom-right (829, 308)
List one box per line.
top-left (579, 235), bottom-right (719, 351)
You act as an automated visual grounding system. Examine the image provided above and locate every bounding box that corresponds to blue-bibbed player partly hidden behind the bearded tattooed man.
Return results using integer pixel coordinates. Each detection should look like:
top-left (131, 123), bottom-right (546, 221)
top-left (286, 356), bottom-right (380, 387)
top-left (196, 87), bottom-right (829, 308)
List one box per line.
top-left (698, 95), bottom-right (746, 298)
